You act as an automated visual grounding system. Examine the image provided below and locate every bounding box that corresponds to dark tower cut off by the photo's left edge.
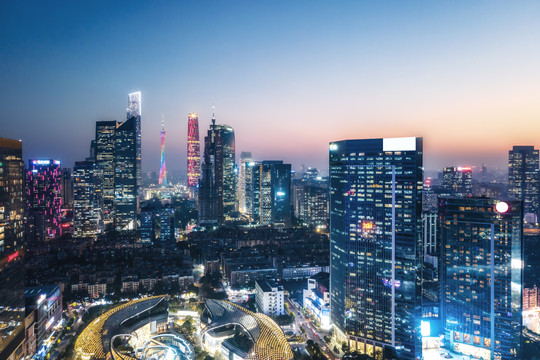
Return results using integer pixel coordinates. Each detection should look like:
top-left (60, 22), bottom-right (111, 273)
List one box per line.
top-left (0, 138), bottom-right (25, 360)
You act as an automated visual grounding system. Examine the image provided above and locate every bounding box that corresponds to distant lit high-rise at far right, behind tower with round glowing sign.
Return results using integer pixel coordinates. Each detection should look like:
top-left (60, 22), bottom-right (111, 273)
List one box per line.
top-left (508, 146), bottom-right (540, 220)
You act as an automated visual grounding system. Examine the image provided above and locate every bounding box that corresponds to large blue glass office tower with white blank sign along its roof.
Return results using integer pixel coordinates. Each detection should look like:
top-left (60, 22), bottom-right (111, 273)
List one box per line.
top-left (330, 137), bottom-right (423, 359)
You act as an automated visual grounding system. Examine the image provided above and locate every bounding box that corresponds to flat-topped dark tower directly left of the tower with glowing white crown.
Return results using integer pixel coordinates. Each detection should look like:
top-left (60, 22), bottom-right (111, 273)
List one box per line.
top-left (95, 121), bottom-right (121, 224)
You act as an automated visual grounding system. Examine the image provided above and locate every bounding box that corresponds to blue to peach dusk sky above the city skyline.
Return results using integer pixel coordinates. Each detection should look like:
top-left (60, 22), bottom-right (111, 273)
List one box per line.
top-left (0, 0), bottom-right (540, 172)
